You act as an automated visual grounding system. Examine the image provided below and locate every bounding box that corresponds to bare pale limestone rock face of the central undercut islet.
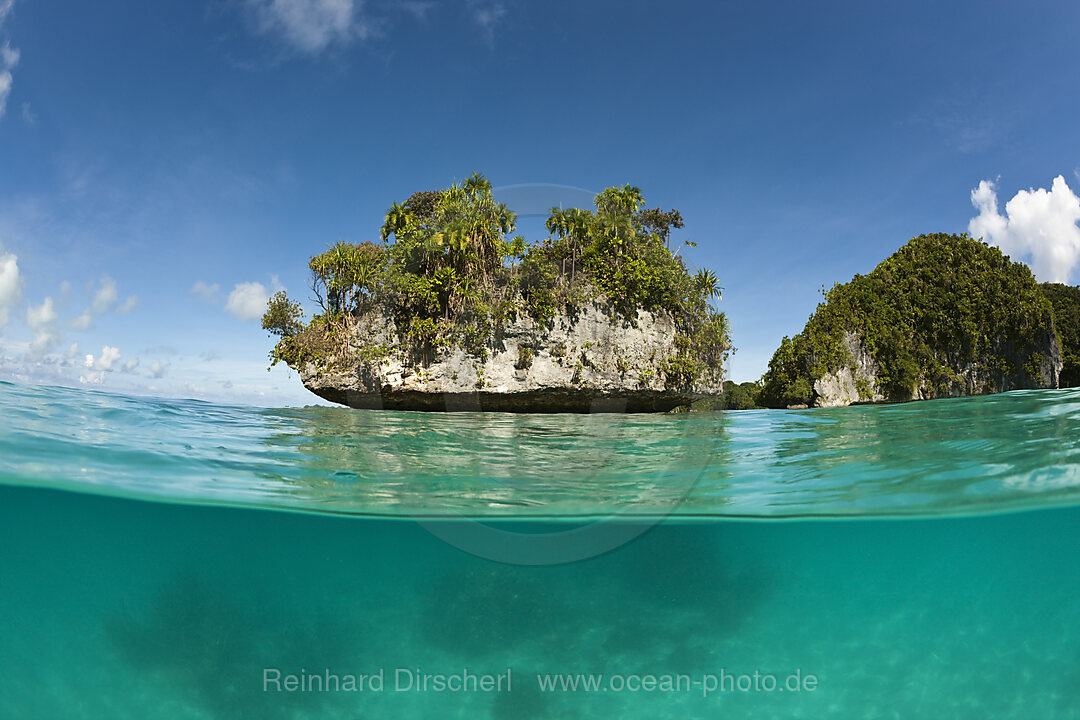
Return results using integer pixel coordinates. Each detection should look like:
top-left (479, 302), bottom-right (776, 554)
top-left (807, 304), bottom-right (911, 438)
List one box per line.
top-left (300, 302), bottom-right (723, 412)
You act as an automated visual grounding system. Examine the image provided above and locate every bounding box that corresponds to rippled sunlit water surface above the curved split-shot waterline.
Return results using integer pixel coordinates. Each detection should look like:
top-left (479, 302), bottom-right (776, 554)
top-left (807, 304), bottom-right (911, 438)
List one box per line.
top-left (0, 383), bottom-right (1080, 517)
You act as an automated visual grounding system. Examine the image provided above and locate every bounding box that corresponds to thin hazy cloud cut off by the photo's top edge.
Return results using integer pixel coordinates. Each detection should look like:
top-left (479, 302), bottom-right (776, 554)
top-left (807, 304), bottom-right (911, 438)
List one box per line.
top-left (248, 0), bottom-right (369, 54)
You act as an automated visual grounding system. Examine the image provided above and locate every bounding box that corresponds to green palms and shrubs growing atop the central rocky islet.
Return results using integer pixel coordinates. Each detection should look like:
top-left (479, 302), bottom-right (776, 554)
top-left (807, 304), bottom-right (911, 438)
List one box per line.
top-left (262, 175), bottom-right (731, 388)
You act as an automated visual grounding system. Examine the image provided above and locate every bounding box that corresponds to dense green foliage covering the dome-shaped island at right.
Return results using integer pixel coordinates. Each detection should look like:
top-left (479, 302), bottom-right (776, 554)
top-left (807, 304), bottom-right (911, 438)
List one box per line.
top-left (761, 233), bottom-right (1051, 407)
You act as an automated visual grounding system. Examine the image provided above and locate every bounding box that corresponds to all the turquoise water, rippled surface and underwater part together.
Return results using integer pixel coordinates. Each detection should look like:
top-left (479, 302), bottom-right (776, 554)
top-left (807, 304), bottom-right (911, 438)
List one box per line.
top-left (0, 383), bottom-right (1080, 720)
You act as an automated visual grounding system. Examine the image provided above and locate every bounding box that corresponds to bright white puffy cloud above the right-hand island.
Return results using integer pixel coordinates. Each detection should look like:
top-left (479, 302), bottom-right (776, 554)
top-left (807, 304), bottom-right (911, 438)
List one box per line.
top-left (968, 175), bottom-right (1080, 283)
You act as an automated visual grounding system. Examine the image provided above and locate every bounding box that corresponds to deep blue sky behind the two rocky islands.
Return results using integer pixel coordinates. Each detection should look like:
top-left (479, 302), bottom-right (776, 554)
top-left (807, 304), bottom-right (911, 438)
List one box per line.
top-left (0, 0), bottom-right (1080, 405)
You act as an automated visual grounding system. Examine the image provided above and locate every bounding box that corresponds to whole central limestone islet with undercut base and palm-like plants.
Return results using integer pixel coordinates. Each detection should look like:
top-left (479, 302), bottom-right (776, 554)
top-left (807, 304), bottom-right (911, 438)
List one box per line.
top-left (262, 175), bottom-right (731, 412)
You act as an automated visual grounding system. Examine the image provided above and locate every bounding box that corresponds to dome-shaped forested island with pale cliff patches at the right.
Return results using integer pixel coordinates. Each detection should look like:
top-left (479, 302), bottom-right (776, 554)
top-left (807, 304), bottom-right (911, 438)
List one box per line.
top-left (746, 233), bottom-right (1078, 408)
